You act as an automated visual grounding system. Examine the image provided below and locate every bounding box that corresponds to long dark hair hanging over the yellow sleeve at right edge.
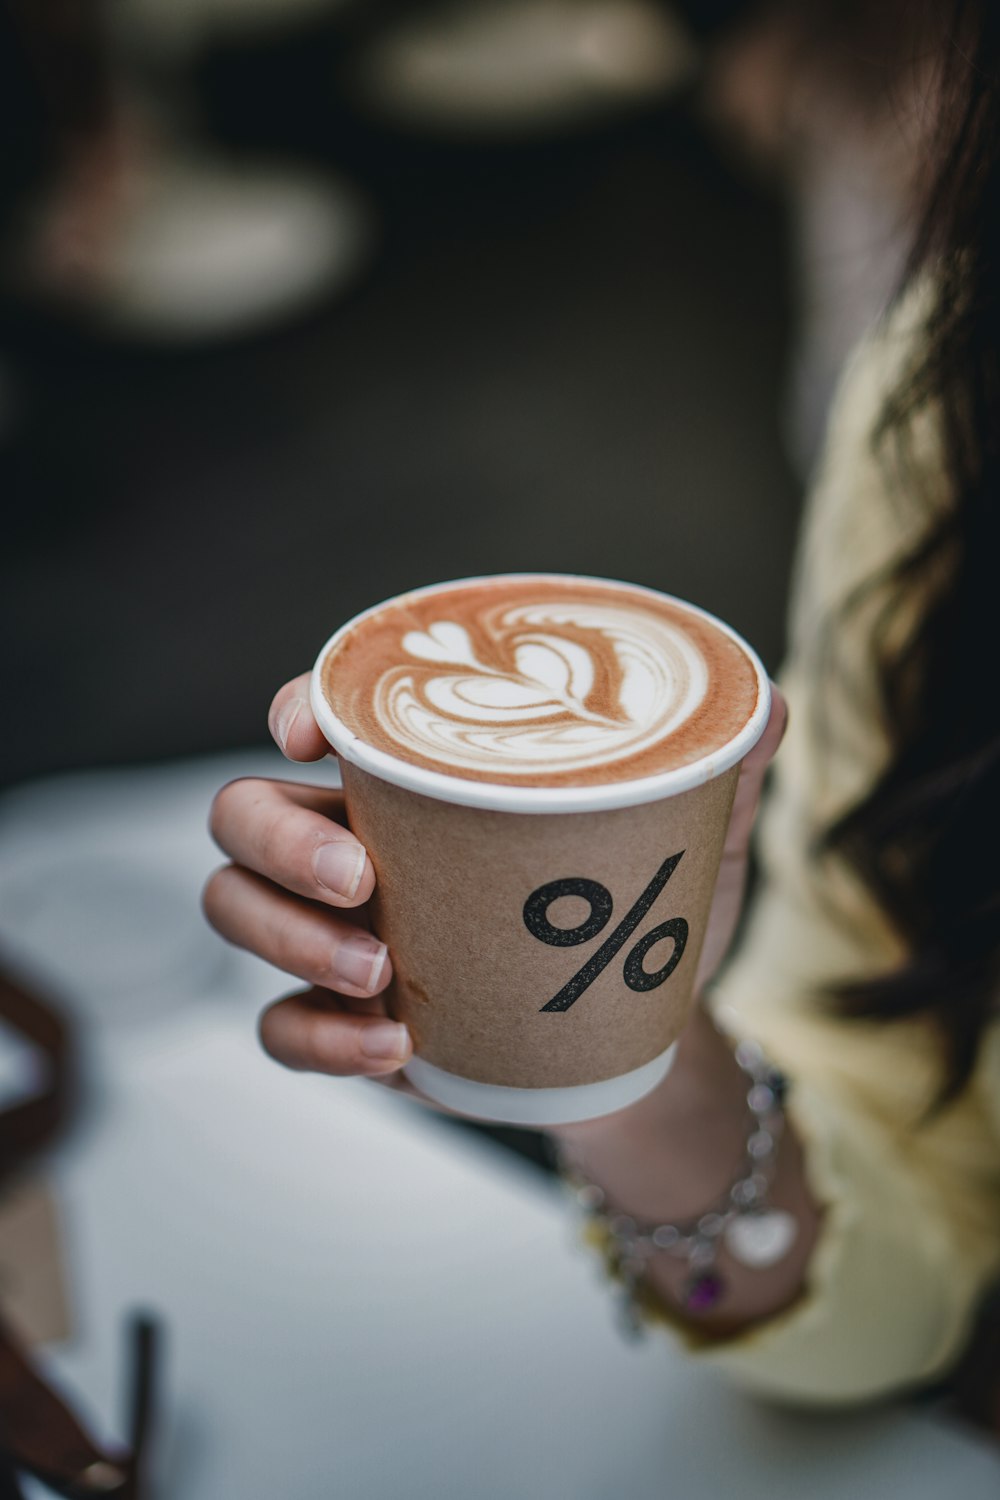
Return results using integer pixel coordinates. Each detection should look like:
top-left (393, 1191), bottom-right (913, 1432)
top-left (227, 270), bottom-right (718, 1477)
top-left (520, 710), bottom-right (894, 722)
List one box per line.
top-left (825, 0), bottom-right (1000, 1103)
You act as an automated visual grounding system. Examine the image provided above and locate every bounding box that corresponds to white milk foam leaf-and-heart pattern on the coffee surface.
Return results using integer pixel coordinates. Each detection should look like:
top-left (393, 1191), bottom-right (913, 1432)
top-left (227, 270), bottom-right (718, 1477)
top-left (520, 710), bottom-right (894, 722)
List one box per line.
top-left (372, 603), bottom-right (708, 776)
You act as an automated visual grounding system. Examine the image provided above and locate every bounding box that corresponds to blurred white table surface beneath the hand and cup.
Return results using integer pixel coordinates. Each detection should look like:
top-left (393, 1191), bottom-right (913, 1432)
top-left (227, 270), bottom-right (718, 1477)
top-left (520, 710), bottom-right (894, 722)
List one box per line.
top-left (0, 753), bottom-right (1000, 1500)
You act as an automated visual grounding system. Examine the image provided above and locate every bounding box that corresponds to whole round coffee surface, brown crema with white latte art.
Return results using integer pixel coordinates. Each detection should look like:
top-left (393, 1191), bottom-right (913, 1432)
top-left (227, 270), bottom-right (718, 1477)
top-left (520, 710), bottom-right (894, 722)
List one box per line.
top-left (321, 576), bottom-right (757, 788)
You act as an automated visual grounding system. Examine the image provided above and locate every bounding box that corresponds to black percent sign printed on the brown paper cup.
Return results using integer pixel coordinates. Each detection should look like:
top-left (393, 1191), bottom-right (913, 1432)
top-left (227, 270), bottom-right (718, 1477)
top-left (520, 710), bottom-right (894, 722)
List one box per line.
top-left (523, 849), bottom-right (688, 1011)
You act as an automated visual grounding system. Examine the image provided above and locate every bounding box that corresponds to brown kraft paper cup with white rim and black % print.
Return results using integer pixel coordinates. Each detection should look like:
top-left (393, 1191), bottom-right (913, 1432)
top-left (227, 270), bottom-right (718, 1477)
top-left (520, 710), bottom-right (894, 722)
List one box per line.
top-left (312, 575), bottom-right (771, 1125)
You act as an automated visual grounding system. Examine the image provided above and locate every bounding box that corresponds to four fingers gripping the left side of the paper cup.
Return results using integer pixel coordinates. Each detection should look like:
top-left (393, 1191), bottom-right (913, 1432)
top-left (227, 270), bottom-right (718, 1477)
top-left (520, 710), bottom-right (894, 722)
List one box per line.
top-left (204, 677), bottom-right (412, 1077)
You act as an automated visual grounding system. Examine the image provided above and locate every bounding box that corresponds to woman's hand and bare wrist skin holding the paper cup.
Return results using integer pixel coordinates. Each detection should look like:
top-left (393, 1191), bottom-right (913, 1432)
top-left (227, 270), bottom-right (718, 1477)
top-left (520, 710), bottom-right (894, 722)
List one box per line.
top-left (223, 677), bottom-right (820, 1332)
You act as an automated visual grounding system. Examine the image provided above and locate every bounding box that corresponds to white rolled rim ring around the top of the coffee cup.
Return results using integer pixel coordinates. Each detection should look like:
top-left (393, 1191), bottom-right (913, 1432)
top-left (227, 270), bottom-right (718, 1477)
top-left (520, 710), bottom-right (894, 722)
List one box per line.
top-left (310, 573), bottom-right (771, 813)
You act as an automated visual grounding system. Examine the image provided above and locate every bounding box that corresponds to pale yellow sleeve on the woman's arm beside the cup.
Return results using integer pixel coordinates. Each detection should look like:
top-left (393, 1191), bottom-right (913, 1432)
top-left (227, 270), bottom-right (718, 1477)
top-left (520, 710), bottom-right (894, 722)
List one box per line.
top-left (664, 292), bottom-right (1000, 1403)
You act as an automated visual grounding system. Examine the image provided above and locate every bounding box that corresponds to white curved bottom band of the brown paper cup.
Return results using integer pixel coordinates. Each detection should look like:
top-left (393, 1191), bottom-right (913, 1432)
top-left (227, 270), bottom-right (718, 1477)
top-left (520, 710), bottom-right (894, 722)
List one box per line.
top-left (403, 1043), bottom-right (678, 1125)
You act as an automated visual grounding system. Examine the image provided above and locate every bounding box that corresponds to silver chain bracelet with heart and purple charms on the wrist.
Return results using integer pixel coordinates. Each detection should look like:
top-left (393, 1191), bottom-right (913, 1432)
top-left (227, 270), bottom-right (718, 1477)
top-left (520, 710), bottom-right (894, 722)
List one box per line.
top-left (559, 1040), bottom-right (799, 1335)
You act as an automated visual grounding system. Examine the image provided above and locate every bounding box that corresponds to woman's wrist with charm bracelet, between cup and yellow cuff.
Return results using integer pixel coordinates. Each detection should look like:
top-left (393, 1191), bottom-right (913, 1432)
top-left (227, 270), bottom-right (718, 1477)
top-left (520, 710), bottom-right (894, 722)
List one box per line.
top-left (562, 1029), bottom-right (819, 1332)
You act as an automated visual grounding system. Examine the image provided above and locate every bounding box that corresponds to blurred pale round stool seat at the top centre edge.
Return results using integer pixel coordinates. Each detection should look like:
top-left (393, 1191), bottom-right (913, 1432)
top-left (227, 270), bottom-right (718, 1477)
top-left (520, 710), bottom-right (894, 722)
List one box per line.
top-left (358, 0), bottom-right (696, 132)
